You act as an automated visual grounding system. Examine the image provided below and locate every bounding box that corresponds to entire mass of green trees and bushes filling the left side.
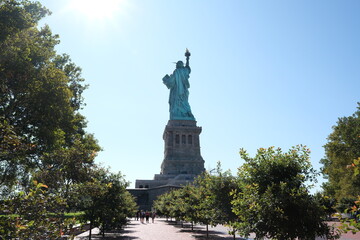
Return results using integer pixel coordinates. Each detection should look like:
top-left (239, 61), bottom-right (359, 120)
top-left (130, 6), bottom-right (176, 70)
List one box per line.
top-left (0, 0), bottom-right (136, 239)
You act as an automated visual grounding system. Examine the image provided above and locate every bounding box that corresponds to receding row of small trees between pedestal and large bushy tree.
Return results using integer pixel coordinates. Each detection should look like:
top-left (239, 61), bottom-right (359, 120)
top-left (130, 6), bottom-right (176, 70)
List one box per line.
top-left (154, 163), bottom-right (237, 237)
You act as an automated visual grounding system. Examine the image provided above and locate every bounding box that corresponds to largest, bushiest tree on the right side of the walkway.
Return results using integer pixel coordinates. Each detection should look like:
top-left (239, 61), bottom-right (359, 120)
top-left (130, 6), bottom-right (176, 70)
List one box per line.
top-left (232, 145), bottom-right (338, 240)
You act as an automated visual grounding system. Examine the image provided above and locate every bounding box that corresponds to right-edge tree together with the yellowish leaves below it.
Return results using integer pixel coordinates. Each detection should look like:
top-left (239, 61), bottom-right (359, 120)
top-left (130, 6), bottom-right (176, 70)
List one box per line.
top-left (321, 103), bottom-right (360, 232)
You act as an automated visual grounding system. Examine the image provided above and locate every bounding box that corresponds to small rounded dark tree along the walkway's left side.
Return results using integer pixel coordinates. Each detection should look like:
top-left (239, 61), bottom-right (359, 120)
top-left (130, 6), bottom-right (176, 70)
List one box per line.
top-left (73, 168), bottom-right (137, 239)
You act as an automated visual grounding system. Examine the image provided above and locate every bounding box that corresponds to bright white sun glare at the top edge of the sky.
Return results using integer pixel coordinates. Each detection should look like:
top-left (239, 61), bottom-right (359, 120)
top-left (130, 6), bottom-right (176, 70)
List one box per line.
top-left (70, 0), bottom-right (124, 21)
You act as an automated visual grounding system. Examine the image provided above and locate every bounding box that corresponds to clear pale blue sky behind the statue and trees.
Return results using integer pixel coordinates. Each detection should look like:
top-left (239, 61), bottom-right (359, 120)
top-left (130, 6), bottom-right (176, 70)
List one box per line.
top-left (40, 0), bottom-right (360, 191)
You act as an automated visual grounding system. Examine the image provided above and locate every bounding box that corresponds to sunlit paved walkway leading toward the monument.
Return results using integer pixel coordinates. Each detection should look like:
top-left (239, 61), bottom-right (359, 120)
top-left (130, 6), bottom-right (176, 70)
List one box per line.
top-left (75, 218), bottom-right (360, 240)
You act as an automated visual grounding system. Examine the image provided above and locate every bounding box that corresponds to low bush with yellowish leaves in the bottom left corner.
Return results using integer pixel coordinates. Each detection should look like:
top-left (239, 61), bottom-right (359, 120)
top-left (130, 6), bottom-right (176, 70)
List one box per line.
top-left (0, 182), bottom-right (74, 239)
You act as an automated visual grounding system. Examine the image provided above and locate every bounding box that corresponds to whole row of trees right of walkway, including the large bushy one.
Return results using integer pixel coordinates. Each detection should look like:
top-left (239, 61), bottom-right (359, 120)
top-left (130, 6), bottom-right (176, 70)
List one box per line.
top-left (155, 145), bottom-right (337, 240)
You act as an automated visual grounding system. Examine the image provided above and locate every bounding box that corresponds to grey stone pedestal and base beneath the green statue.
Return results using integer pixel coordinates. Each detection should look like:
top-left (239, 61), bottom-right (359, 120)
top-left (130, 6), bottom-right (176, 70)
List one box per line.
top-left (128, 120), bottom-right (205, 210)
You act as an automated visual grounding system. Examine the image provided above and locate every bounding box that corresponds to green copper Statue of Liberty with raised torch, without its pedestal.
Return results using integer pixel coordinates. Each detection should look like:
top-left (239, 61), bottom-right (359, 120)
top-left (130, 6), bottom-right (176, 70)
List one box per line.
top-left (162, 49), bottom-right (195, 120)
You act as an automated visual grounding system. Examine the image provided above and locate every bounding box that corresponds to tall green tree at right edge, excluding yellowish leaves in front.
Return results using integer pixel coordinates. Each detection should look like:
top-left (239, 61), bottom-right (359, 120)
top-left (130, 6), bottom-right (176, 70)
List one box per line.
top-left (321, 103), bottom-right (360, 201)
